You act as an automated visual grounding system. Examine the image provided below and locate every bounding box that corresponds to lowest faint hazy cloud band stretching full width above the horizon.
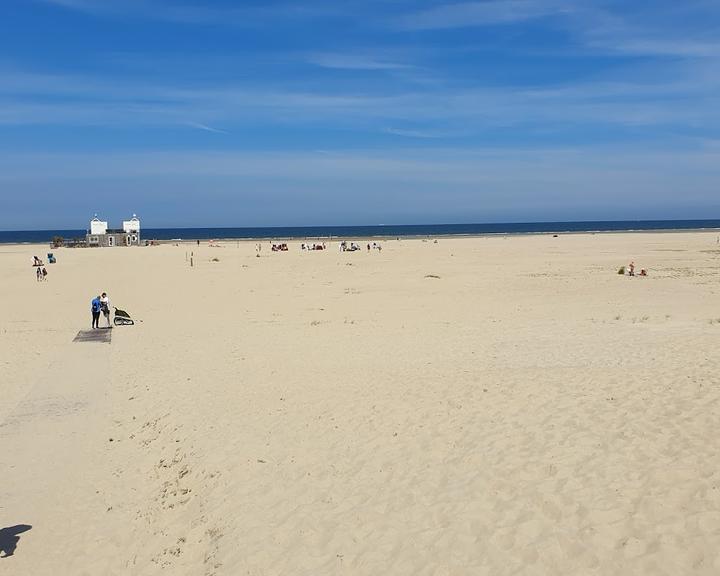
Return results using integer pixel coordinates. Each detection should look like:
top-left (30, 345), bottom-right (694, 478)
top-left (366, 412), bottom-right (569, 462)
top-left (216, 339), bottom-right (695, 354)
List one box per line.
top-left (0, 145), bottom-right (720, 183)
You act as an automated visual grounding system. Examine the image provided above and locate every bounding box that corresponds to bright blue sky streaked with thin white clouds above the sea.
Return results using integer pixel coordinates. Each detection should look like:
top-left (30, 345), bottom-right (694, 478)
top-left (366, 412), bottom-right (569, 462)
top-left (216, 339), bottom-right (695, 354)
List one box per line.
top-left (0, 0), bottom-right (720, 230)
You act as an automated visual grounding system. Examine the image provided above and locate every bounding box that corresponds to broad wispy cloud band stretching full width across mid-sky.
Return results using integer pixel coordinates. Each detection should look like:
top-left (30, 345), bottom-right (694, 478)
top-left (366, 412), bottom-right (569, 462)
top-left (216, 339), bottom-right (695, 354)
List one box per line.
top-left (0, 69), bottom-right (720, 133)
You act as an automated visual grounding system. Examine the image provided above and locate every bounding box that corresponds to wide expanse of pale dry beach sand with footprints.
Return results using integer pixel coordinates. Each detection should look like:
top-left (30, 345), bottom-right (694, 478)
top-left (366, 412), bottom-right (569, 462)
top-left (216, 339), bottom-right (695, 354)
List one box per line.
top-left (0, 233), bottom-right (720, 576)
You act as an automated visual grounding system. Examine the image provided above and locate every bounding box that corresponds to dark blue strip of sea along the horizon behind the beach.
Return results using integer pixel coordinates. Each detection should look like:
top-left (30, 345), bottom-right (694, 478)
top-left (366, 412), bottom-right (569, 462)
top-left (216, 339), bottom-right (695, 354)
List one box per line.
top-left (0, 220), bottom-right (720, 244)
